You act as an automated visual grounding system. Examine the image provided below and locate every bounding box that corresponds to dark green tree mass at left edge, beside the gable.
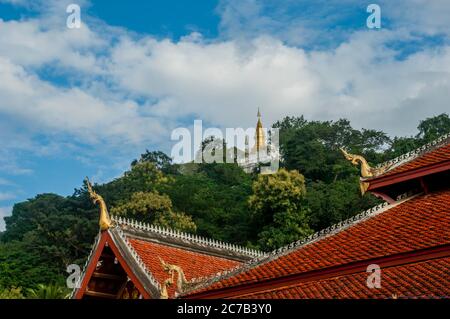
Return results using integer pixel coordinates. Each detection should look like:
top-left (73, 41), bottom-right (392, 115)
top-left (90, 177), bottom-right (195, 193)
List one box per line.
top-left (0, 194), bottom-right (98, 289)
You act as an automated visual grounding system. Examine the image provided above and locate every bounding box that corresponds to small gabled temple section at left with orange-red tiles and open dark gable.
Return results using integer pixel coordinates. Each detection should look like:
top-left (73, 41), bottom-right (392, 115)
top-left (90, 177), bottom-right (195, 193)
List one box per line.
top-left (68, 210), bottom-right (262, 299)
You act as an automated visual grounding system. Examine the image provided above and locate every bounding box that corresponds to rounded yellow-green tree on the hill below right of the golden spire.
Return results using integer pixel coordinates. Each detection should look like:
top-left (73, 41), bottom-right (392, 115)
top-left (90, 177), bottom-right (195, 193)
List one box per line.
top-left (249, 169), bottom-right (312, 250)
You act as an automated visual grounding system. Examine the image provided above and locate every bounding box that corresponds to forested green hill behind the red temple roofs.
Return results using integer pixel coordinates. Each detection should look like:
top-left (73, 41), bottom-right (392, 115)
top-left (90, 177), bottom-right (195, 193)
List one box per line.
top-left (0, 114), bottom-right (450, 298)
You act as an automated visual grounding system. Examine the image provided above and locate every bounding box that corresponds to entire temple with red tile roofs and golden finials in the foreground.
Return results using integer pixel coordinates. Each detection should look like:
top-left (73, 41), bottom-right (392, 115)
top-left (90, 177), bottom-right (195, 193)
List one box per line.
top-left (72, 135), bottom-right (450, 299)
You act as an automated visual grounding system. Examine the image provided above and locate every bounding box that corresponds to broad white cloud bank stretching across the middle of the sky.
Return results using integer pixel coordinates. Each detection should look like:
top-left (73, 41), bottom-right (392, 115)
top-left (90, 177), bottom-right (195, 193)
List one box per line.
top-left (0, 0), bottom-right (450, 180)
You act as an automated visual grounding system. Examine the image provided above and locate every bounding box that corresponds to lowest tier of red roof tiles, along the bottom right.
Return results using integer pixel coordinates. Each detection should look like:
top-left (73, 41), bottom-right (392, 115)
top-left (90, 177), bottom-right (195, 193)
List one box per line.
top-left (238, 257), bottom-right (450, 299)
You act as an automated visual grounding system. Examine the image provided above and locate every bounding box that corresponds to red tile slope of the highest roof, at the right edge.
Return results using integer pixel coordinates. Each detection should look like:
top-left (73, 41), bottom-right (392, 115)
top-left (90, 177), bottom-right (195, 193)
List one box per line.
top-left (370, 143), bottom-right (450, 180)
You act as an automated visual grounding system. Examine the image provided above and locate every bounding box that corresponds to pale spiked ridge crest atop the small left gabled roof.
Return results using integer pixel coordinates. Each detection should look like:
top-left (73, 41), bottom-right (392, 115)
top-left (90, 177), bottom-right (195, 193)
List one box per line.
top-left (111, 216), bottom-right (265, 257)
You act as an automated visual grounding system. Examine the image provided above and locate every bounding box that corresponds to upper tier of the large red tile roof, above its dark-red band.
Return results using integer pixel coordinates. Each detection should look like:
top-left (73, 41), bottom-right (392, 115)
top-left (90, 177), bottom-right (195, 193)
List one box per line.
top-left (185, 190), bottom-right (450, 298)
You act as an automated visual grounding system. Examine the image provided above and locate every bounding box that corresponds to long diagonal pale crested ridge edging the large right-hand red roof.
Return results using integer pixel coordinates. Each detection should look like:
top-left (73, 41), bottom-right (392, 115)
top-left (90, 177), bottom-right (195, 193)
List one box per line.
top-left (180, 192), bottom-right (417, 296)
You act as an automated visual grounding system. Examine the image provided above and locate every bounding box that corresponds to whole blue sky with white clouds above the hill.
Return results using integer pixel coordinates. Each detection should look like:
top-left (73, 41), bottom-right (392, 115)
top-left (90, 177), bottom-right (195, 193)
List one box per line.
top-left (0, 0), bottom-right (450, 230)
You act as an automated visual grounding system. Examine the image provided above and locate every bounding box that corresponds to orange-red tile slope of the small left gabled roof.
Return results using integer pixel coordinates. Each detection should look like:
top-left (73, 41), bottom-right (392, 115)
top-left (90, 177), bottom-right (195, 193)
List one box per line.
top-left (129, 238), bottom-right (241, 297)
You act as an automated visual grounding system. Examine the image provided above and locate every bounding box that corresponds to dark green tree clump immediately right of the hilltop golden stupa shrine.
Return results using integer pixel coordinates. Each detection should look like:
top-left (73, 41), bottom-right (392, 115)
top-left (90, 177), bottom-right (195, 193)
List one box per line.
top-left (274, 117), bottom-right (390, 183)
